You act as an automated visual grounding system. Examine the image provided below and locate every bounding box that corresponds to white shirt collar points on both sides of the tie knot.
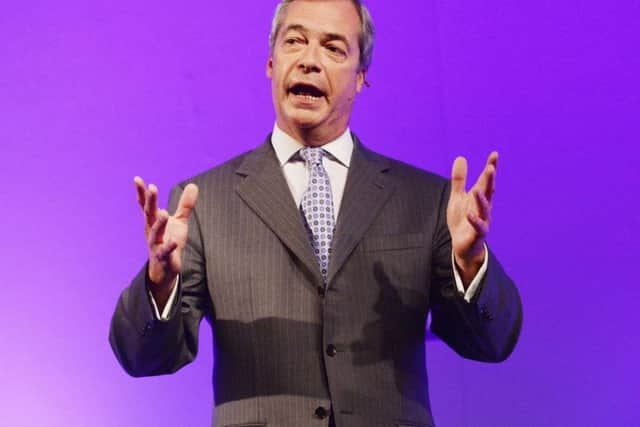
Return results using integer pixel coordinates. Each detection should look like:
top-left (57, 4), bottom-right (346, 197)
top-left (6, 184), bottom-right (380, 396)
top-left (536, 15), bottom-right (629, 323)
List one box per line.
top-left (271, 123), bottom-right (353, 168)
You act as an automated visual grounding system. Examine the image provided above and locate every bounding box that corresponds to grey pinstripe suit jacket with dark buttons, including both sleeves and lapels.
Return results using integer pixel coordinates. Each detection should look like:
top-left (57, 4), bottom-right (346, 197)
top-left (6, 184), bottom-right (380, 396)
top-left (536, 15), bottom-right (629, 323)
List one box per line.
top-left (110, 136), bottom-right (522, 427)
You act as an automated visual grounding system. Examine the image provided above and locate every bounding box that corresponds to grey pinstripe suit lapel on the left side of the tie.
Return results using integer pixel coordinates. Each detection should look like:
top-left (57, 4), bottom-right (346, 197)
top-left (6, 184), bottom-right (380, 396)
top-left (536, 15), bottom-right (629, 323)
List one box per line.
top-left (236, 137), bottom-right (322, 285)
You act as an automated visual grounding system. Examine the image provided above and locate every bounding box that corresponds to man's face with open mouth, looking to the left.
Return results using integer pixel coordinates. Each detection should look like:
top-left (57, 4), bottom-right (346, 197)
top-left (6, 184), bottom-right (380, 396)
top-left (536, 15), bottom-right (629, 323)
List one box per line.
top-left (267, 0), bottom-right (364, 142)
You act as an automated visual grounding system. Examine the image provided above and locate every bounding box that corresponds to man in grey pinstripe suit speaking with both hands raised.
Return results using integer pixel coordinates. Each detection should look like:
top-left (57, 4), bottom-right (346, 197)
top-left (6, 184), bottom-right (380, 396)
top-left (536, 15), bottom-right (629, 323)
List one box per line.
top-left (110, 0), bottom-right (521, 427)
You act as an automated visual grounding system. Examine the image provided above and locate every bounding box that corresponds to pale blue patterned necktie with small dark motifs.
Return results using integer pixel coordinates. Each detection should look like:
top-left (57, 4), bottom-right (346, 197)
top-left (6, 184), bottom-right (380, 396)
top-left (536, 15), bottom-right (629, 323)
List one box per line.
top-left (300, 147), bottom-right (334, 284)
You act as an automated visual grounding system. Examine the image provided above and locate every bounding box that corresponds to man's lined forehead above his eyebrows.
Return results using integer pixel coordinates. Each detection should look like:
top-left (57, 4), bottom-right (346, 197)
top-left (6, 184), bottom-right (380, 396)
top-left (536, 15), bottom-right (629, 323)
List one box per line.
top-left (281, 0), bottom-right (360, 41)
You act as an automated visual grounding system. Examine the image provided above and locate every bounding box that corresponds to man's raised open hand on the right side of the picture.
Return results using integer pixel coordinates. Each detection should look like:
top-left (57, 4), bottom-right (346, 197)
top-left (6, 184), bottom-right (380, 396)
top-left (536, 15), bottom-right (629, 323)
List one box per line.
top-left (447, 151), bottom-right (498, 286)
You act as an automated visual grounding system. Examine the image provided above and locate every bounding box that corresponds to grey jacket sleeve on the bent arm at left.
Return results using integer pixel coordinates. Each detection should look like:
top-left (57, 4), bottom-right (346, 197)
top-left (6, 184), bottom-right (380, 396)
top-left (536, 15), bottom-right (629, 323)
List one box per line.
top-left (109, 182), bottom-right (212, 377)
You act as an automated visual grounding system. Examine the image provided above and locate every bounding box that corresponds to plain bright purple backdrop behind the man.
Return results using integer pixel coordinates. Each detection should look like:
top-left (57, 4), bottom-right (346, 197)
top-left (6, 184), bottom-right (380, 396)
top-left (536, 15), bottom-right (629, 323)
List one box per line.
top-left (0, 0), bottom-right (640, 427)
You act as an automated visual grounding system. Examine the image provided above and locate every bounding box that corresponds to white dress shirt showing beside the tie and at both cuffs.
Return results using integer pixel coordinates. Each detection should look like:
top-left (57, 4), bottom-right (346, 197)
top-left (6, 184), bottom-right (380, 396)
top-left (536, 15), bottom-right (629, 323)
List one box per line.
top-left (150, 124), bottom-right (488, 320)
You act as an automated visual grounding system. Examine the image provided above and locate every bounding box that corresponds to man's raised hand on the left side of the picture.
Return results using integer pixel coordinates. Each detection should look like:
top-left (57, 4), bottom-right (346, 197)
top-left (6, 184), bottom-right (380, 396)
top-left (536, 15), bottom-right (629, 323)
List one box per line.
top-left (133, 176), bottom-right (198, 311)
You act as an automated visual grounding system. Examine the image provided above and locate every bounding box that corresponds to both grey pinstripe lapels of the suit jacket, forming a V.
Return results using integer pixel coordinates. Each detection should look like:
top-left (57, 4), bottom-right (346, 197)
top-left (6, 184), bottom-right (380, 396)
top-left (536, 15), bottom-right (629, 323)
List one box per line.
top-left (236, 133), bottom-right (394, 286)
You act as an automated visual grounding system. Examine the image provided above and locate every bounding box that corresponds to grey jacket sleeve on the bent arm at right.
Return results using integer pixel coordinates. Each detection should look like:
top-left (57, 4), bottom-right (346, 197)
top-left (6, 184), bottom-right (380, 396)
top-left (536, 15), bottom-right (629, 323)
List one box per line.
top-left (430, 183), bottom-right (522, 362)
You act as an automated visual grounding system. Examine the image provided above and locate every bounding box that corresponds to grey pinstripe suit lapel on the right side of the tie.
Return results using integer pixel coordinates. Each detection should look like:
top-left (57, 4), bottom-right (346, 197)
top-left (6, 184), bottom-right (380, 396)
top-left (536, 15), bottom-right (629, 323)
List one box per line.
top-left (327, 135), bottom-right (394, 283)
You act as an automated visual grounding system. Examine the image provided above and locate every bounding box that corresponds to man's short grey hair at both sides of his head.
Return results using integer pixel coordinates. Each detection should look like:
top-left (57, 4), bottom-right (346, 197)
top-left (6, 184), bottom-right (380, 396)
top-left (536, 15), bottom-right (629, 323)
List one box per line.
top-left (269, 0), bottom-right (375, 71)
